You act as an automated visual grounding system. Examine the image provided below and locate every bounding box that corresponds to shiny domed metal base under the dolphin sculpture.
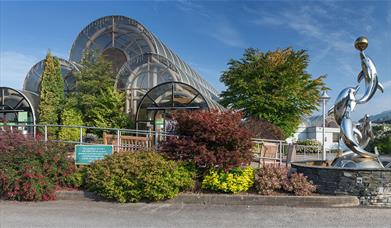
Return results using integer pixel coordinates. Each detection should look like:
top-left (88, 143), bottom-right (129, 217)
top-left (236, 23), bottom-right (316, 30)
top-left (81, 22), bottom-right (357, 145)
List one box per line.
top-left (331, 152), bottom-right (384, 169)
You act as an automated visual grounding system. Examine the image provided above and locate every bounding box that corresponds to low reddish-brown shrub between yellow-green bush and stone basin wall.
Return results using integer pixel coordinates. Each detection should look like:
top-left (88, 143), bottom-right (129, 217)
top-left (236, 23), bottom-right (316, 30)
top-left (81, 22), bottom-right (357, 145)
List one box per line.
top-left (255, 165), bottom-right (316, 196)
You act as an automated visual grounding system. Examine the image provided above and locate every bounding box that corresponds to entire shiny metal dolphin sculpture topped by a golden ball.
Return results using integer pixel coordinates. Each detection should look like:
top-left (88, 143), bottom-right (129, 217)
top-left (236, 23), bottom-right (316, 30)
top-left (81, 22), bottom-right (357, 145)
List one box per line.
top-left (332, 37), bottom-right (384, 168)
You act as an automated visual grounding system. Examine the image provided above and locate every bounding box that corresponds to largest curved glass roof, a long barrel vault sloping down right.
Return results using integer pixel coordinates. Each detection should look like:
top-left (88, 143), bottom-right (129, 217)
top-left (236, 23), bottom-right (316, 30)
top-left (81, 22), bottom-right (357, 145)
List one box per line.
top-left (69, 16), bottom-right (219, 104)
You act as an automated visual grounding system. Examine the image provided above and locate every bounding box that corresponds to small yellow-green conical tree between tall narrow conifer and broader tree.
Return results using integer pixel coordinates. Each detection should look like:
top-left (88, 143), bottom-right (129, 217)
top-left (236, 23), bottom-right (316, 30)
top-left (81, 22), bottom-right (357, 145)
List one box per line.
top-left (59, 97), bottom-right (86, 141)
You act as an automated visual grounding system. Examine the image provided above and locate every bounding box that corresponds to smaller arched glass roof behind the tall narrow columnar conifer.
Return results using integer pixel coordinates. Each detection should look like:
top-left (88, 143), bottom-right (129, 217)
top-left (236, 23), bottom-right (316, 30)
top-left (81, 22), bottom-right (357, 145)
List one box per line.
top-left (23, 57), bottom-right (80, 94)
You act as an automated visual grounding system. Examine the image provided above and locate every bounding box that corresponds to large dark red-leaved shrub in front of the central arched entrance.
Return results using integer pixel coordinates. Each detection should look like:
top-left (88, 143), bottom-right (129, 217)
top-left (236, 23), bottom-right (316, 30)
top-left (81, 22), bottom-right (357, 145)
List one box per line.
top-left (160, 110), bottom-right (252, 170)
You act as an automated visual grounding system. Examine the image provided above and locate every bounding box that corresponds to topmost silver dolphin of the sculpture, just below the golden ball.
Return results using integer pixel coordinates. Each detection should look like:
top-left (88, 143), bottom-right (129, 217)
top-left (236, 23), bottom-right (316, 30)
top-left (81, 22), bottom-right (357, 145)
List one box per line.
top-left (357, 51), bottom-right (384, 104)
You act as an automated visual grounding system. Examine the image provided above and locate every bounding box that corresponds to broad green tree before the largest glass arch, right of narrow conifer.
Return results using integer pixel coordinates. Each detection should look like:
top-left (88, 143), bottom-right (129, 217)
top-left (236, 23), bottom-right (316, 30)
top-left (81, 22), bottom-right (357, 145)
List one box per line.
top-left (74, 51), bottom-right (130, 128)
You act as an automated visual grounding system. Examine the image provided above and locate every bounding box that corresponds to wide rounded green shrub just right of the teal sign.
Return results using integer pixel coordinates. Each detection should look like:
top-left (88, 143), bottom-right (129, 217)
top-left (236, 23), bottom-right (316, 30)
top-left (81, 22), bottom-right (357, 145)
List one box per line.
top-left (85, 151), bottom-right (195, 203)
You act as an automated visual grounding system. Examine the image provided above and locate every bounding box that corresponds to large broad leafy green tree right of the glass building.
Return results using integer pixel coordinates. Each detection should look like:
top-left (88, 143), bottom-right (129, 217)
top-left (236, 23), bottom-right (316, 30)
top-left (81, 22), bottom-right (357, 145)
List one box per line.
top-left (220, 48), bottom-right (325, 137)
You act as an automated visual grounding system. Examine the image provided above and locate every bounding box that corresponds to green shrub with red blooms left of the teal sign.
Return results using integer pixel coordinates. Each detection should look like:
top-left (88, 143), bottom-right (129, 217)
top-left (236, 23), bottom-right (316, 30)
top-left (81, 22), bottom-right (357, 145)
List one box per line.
top-left (0, 131), bottom-right (75, 201)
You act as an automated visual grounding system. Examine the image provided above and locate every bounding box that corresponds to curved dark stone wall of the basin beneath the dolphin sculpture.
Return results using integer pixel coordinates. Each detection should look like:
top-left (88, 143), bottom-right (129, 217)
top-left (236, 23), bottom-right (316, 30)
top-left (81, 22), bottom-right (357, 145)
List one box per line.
top-left (292, 161), bottom-right (391, 207)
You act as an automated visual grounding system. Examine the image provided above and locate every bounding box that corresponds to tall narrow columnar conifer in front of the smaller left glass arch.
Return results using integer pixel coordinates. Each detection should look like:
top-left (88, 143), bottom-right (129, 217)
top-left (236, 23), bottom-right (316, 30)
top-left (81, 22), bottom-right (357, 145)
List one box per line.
top-left (39, 52), bottom-right (64, 135)
